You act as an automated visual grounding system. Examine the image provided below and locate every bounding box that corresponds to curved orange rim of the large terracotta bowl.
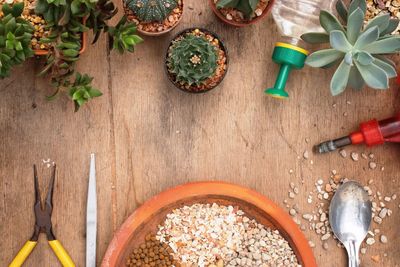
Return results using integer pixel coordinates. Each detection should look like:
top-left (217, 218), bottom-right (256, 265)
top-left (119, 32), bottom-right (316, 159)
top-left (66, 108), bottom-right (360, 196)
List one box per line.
top-left (101, 182), bottom-right (317, 267)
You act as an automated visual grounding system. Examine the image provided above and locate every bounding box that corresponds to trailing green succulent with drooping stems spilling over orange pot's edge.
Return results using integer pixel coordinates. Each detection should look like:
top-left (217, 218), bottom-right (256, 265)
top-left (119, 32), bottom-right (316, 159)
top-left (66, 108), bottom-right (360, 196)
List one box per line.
top-left (35, 0), bottom-right (142, 110)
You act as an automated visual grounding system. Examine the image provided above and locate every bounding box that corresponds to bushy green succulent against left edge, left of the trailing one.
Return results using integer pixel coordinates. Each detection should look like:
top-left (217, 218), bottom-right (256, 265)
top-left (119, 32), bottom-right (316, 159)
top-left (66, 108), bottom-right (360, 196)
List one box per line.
top-left (0, 3), bottom-right (33, 78)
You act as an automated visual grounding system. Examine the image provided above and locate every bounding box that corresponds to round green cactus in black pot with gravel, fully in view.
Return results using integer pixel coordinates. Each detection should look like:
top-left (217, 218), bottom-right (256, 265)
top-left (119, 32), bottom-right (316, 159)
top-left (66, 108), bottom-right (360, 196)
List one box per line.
top-left (165, 28), bottom-right (228, 93)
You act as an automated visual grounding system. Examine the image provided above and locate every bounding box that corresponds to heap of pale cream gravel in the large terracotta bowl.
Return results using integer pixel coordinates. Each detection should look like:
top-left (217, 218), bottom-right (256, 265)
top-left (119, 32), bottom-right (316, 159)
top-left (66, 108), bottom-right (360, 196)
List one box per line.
top-left (156, 203), bottom-right (300, 267)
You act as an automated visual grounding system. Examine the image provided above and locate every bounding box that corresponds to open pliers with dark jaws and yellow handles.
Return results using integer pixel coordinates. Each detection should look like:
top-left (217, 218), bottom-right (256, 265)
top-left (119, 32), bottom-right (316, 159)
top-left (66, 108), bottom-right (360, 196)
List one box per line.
top-left (9, 165), bottom-right (75, 267)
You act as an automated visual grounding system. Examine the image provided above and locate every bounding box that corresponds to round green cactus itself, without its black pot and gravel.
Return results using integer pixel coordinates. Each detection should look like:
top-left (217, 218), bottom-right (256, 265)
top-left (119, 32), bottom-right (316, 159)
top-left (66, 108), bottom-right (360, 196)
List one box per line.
top-left (167, 33), bottom-right (218, 86)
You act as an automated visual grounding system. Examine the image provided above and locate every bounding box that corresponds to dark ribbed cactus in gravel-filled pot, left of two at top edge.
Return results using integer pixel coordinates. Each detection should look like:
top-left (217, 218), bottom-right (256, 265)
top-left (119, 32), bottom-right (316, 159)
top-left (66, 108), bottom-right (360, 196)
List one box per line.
top-left (123, 0), bottom-right (183, 36)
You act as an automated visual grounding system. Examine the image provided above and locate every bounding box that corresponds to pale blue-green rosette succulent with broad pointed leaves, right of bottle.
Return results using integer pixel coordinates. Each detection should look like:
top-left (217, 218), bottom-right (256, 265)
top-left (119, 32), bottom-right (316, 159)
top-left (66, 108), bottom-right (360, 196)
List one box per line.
top-left (302, 0), bottom-right (400, 95)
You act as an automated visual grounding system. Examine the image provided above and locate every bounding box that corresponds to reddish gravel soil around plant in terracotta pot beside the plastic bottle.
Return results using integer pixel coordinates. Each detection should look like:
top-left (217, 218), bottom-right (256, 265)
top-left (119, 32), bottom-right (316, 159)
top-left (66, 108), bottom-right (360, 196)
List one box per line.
top-left (211, 0), bottom-right (272, 26)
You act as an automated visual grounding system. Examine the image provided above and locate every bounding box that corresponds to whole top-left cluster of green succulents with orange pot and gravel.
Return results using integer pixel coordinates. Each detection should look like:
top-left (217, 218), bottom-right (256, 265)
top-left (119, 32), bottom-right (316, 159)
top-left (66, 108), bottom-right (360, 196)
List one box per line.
top-left (0, 0), bottom-right (142, 110)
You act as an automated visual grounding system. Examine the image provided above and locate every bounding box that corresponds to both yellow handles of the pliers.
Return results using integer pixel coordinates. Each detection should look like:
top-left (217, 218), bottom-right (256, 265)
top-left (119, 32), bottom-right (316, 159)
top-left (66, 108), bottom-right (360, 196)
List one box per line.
top-left (9, 240), bottom-right (75, 267)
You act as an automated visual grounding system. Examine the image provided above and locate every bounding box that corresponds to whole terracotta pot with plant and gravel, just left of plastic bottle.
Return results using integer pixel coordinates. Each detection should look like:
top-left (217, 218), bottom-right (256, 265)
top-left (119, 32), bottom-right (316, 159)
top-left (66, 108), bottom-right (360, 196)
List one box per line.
top-left (209, 0), bottom-right (275, 27)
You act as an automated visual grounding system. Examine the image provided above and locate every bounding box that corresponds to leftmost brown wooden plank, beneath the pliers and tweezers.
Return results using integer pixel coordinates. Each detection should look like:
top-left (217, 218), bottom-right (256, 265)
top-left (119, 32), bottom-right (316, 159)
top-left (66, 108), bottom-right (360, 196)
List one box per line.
top-left (0, 33), bottom-right (114, 266)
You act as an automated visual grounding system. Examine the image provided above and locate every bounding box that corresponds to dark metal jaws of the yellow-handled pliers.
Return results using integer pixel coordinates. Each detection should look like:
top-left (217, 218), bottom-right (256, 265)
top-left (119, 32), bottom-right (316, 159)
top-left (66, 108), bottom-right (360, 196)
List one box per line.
top-left (30, 165), bottom-right (56, 241)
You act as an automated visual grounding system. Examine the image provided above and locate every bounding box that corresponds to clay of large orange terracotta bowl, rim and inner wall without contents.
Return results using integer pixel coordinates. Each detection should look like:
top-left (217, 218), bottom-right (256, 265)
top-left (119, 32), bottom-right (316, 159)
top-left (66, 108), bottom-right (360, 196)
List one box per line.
top-left (101, 182), bottom-right (317, 267)
